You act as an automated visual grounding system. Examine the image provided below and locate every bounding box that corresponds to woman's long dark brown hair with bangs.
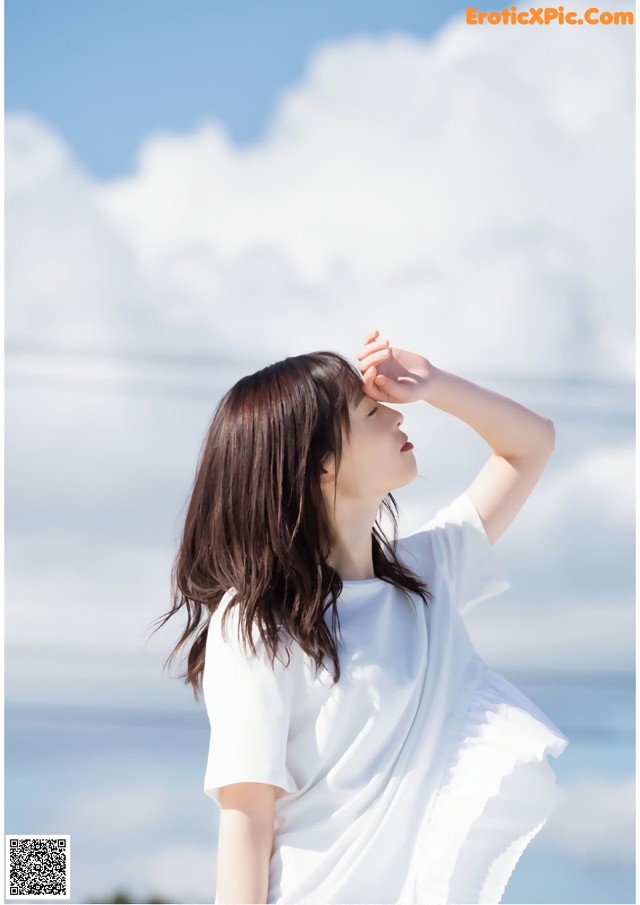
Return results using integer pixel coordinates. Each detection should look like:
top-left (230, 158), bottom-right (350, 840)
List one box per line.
top-left (148, 352), bottom-right (432, 700)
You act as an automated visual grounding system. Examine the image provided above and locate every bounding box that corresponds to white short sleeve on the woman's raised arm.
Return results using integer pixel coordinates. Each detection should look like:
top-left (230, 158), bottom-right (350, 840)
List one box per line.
top-left (422, 491), bottom-right (511, 613)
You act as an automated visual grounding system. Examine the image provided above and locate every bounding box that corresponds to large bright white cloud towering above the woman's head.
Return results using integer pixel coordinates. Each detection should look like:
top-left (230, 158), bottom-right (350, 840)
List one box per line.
top-left (86, 0), bottom-right (633, 374)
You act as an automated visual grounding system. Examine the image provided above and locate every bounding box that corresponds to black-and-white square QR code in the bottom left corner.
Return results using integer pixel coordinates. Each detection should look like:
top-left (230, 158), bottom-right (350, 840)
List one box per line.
top-left (5, 835), bottom-right (71, 899)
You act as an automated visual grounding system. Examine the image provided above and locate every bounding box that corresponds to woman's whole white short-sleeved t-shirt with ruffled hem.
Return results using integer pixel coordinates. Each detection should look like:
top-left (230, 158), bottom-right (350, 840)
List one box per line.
top-left (203, 492), bottom-right (568, 905)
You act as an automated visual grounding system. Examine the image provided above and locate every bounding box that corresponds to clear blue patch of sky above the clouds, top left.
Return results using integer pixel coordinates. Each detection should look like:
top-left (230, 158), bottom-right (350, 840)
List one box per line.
top-left (5, 0), bottom-right (464, 178)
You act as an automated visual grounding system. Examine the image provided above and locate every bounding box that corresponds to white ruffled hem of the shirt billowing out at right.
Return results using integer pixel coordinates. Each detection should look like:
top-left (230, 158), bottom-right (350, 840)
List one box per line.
top-left (398, 666), bottom-right (569, 905)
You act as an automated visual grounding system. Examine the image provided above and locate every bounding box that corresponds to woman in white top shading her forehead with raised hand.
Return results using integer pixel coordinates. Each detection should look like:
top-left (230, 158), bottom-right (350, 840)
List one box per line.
top-left (158, 331), bottom-right (568, 905)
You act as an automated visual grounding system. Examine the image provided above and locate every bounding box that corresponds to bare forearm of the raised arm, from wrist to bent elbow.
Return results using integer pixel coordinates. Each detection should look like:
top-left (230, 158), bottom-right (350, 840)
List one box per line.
top-left (425, 365), bottom-right (554, 459)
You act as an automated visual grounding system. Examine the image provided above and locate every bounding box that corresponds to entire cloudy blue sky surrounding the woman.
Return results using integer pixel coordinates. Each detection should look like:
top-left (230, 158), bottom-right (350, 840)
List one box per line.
top-left (5, 0), bottom-right (635, 902)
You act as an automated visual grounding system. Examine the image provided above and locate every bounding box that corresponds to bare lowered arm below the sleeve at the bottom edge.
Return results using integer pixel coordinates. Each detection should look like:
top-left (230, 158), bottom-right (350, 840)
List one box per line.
top-left (216, 808), bottom-right (273, 905)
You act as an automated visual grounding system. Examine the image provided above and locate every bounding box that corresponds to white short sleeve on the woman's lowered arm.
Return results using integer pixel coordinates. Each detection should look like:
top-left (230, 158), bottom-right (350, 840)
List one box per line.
top-left (202, 605), bottom-right (298, 805)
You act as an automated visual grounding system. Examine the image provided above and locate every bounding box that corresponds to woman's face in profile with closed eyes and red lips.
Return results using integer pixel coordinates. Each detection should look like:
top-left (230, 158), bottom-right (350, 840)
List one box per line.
top-left (324, 394), bottom-right (418, 501)
